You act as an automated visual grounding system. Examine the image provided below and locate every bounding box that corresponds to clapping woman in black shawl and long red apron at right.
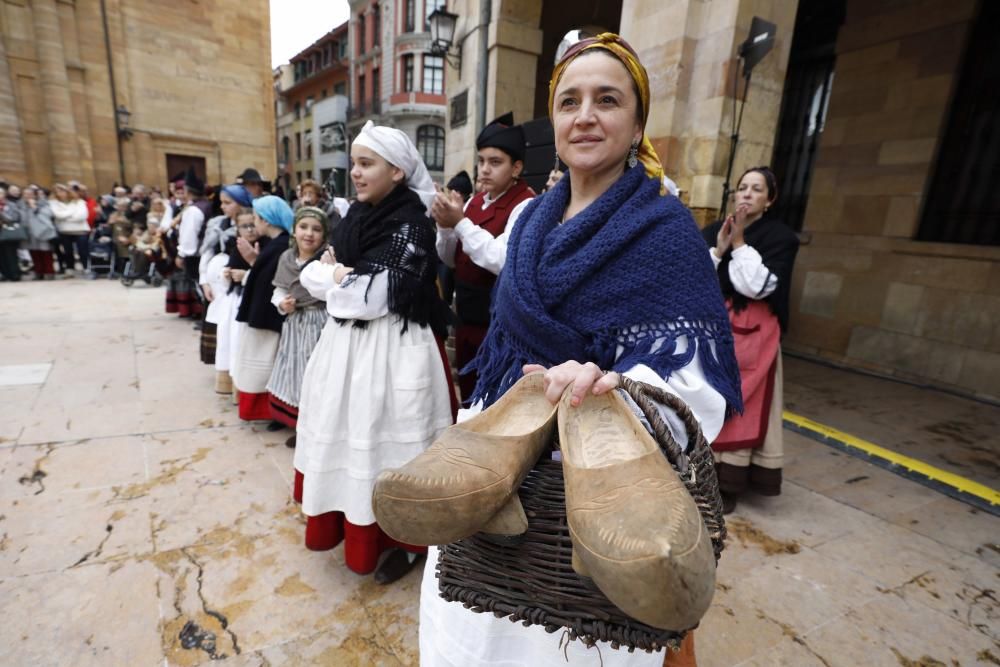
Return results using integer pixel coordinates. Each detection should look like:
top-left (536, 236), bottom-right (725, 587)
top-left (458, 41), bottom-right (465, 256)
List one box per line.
top-left (703, 167), bottom-right (799, 513)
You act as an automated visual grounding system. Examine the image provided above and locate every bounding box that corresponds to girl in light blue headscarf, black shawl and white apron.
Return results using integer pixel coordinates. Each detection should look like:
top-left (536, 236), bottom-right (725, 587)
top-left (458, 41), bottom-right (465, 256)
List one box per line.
top-left (233, 195), bottom-right (293, 422)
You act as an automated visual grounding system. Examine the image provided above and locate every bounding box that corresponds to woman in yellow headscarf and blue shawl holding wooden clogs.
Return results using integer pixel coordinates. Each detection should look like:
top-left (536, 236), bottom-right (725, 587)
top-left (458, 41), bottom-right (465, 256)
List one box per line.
top-left (420, 33), bottom-right (741, 667)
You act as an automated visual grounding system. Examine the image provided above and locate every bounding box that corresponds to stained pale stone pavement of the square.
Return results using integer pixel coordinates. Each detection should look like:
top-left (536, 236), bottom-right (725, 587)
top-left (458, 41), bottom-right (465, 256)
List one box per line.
top-left (0, 280), bottom-right (1000, 667)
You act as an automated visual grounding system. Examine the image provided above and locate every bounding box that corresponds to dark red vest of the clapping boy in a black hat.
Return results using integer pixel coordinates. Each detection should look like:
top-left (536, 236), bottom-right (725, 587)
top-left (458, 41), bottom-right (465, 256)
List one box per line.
top-left (455, 181), bottom-right (535, 326)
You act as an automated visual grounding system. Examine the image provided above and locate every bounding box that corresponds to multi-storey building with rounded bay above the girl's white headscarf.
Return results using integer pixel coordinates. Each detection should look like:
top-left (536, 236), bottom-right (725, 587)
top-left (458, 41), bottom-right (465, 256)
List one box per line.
top-left (348, 0), bottom-right (447, 182)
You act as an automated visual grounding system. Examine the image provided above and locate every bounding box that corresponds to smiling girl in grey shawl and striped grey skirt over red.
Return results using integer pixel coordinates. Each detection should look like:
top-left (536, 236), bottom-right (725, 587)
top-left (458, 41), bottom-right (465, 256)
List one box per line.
top-left (267, 206), bottom-right (328, 447)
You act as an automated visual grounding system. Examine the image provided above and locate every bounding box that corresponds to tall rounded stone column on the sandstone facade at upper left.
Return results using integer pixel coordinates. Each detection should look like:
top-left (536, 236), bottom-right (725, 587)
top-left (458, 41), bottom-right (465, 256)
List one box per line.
top-left (31, 0), bottom-right (81, 181)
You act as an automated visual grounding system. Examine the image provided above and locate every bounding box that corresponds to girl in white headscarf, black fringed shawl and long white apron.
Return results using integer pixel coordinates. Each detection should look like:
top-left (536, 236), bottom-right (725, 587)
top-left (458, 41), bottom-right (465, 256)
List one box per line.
top-left (295, 121), bottom-right (454, 583)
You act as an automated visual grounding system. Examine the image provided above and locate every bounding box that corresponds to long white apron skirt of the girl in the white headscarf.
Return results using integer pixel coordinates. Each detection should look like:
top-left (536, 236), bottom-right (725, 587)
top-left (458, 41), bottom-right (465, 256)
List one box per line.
top-left (295, 314), bottom-right (451, 526)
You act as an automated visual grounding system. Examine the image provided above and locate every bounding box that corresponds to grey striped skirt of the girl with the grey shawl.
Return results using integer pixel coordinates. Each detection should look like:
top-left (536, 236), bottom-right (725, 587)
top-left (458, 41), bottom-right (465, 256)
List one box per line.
top-left (267, 305), bottom-right (329, 412)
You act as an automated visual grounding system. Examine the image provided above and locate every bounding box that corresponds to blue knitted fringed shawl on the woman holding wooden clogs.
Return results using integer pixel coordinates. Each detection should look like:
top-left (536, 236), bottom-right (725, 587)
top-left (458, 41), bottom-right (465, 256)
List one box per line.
top-left (463, 164), bottom-right (742, 412)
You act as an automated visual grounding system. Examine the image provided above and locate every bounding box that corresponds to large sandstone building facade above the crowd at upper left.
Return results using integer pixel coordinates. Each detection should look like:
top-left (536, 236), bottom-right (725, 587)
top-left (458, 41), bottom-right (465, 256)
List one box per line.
top-left (0, 0), bottom-right (275, 191)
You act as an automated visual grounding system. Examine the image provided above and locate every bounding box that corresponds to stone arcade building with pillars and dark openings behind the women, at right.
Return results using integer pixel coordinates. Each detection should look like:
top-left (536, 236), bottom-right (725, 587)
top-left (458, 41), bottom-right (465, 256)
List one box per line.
top-left (445, 0), bottom-right (1000, 399)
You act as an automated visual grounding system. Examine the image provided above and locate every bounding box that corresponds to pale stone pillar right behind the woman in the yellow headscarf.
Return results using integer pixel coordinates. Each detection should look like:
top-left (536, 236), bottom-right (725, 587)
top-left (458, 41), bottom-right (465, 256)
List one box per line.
top-left (621, 0), bottom-right (798, 225)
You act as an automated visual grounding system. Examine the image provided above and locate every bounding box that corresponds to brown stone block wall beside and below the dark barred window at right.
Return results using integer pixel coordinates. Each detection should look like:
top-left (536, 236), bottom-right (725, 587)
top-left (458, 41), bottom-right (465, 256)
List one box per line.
top-left (785, 0), bottom-right (1000, 398)
